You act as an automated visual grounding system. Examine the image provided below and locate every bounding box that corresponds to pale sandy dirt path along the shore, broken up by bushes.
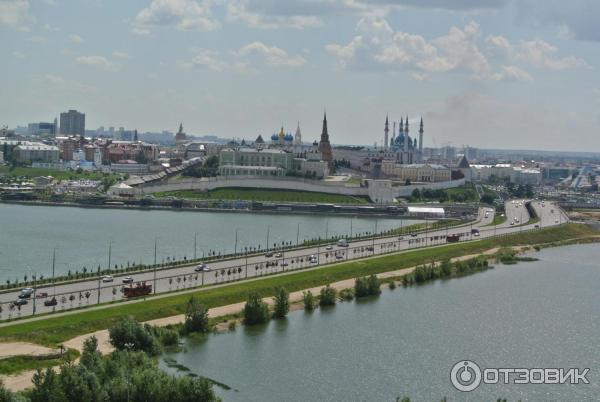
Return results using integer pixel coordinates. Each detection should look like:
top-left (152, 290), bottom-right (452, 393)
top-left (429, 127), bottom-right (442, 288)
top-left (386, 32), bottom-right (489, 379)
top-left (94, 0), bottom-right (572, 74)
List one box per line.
top-left (0, 247), bottom-right (510, 391)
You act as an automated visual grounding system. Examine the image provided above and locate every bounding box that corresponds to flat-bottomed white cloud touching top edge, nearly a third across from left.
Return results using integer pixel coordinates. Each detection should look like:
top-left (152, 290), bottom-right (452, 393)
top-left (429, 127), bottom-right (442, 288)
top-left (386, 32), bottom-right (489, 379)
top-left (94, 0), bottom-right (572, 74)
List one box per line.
top-left (132, 0), bottom-right (221, 35)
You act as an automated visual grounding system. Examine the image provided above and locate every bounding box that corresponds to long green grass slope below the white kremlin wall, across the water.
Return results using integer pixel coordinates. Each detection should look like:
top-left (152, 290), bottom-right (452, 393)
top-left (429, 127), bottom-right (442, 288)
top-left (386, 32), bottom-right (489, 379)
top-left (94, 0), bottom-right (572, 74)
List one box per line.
top-left (154, 187), bottom-right (369, 204)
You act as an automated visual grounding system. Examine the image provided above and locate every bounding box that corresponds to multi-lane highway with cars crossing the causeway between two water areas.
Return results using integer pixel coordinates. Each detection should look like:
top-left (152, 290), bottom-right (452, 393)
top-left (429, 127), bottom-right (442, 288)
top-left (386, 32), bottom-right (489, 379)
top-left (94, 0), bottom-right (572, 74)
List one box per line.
top-left (0, 200), bottom-right (568, 319)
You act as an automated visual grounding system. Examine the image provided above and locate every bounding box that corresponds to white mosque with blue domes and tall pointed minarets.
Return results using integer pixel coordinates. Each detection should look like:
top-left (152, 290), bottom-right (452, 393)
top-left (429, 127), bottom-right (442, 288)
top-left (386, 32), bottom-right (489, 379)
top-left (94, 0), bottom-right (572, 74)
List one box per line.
top-left (383, 116), bottom-right (424, 165)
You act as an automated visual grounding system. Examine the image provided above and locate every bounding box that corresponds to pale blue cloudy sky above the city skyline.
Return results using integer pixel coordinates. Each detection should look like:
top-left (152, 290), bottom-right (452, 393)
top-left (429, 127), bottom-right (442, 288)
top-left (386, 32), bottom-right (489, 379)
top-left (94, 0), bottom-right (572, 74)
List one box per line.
top-left (0, 0), bottom-right (600, 151)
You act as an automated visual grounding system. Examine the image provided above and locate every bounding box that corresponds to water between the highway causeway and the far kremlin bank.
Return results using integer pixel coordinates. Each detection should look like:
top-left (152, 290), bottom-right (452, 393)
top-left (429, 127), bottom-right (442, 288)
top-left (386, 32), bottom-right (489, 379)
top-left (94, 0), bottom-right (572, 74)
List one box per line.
top-left (0, 203), bottom-right (422, 283)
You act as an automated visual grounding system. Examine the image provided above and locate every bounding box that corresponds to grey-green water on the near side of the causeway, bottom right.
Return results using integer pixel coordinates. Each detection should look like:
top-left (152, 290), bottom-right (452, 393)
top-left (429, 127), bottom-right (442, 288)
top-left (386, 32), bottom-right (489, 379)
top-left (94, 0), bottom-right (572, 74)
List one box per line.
top-left (161, 245), bottom-right (600, 402)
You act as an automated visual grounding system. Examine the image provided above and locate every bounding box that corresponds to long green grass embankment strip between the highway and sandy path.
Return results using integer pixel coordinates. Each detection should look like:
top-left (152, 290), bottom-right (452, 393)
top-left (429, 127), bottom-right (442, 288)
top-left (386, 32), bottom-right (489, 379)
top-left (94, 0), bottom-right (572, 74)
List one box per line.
top-left (0, 224), bottom-right (598, 346)
